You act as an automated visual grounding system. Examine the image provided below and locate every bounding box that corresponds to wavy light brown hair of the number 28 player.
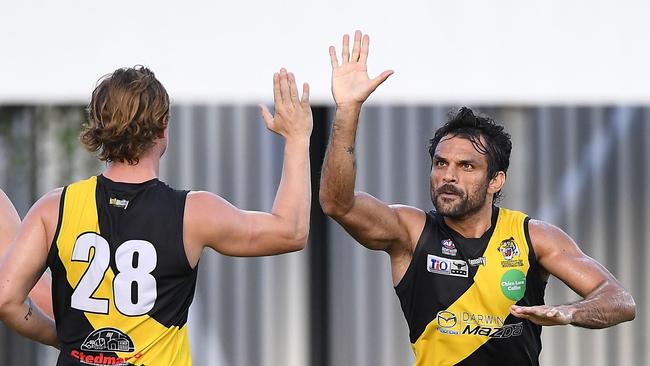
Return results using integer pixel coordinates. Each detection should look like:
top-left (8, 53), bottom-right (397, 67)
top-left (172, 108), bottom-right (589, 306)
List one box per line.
top-left (79, 65), bottom-right (169, 164)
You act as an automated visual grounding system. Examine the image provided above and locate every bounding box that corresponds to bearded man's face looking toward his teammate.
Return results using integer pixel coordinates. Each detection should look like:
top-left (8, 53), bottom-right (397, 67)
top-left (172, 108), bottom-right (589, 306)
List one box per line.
top-left (431, 136), bottom-right (489, 219)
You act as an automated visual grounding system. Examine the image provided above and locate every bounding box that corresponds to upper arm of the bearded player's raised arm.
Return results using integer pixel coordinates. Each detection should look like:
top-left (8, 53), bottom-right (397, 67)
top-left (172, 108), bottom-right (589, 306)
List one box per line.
top-left (324, 192), bottom-right (425, 254)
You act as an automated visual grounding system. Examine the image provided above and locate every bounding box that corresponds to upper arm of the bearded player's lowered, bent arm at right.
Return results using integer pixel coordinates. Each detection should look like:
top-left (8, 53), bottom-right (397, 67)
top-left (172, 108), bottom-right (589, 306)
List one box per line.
top-left (528, 220), bottom-right (618, 297)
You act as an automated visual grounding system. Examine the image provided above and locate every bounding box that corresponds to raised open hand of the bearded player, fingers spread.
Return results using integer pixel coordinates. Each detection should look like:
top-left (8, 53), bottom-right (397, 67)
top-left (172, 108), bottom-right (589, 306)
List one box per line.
top-left (329, 31), bottom-right (393, 107)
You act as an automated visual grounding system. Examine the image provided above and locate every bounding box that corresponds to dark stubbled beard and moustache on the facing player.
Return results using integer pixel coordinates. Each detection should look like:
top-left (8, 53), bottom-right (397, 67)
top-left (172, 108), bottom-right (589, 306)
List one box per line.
top-left (431, 183), bottom-right (488, 220)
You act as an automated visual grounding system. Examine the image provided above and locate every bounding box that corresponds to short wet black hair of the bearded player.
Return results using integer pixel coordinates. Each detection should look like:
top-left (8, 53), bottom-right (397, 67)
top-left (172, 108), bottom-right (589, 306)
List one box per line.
top-left (429, 107), bottom-right (512, 202)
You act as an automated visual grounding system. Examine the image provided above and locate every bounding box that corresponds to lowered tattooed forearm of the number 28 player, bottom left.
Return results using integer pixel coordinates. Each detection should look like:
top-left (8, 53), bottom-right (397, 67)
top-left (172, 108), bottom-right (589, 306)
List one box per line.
top-left (0, 298), bottom-right (59, 348)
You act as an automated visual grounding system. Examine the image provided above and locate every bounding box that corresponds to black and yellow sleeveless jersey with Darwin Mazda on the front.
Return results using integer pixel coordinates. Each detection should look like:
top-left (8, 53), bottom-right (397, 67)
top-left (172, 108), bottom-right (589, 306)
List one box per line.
top-left (395, 207), bottom-right (546, 366)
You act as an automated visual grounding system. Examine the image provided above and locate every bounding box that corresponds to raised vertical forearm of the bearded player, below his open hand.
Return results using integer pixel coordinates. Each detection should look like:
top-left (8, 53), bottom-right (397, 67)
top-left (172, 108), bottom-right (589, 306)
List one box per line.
top-left (319, 106), bottom-right (360, 216)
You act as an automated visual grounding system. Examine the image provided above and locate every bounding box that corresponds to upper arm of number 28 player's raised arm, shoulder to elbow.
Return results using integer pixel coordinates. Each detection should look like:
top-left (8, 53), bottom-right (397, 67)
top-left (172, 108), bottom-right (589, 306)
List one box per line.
top-left (183, 192), bottom-right (307, 262)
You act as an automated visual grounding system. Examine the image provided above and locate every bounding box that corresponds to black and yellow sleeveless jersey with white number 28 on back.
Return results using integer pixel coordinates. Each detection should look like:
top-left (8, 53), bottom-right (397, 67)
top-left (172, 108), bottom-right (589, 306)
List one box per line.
top-left (48, 175), bottom-right (197, 366)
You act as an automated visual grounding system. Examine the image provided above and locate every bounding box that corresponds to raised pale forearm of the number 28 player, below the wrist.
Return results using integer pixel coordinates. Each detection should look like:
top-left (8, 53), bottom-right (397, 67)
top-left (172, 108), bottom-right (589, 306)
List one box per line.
top-left (271, 136), bottom-right (311, 249)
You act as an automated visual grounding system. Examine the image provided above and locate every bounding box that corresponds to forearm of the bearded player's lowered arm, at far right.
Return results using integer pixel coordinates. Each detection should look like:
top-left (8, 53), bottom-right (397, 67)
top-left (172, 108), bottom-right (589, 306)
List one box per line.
top-left (565, 281), bottom-right (636, 329)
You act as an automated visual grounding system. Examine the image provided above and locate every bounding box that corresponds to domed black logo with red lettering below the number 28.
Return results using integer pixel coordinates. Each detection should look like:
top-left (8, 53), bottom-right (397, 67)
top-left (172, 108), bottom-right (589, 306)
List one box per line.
top-left (70, 328), bottom-right (142, 366)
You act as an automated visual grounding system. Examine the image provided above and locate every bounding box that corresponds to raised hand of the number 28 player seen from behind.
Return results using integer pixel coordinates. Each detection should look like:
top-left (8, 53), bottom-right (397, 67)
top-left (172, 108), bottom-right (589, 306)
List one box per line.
top-left (260, 68), bottom-right (313, 139)
